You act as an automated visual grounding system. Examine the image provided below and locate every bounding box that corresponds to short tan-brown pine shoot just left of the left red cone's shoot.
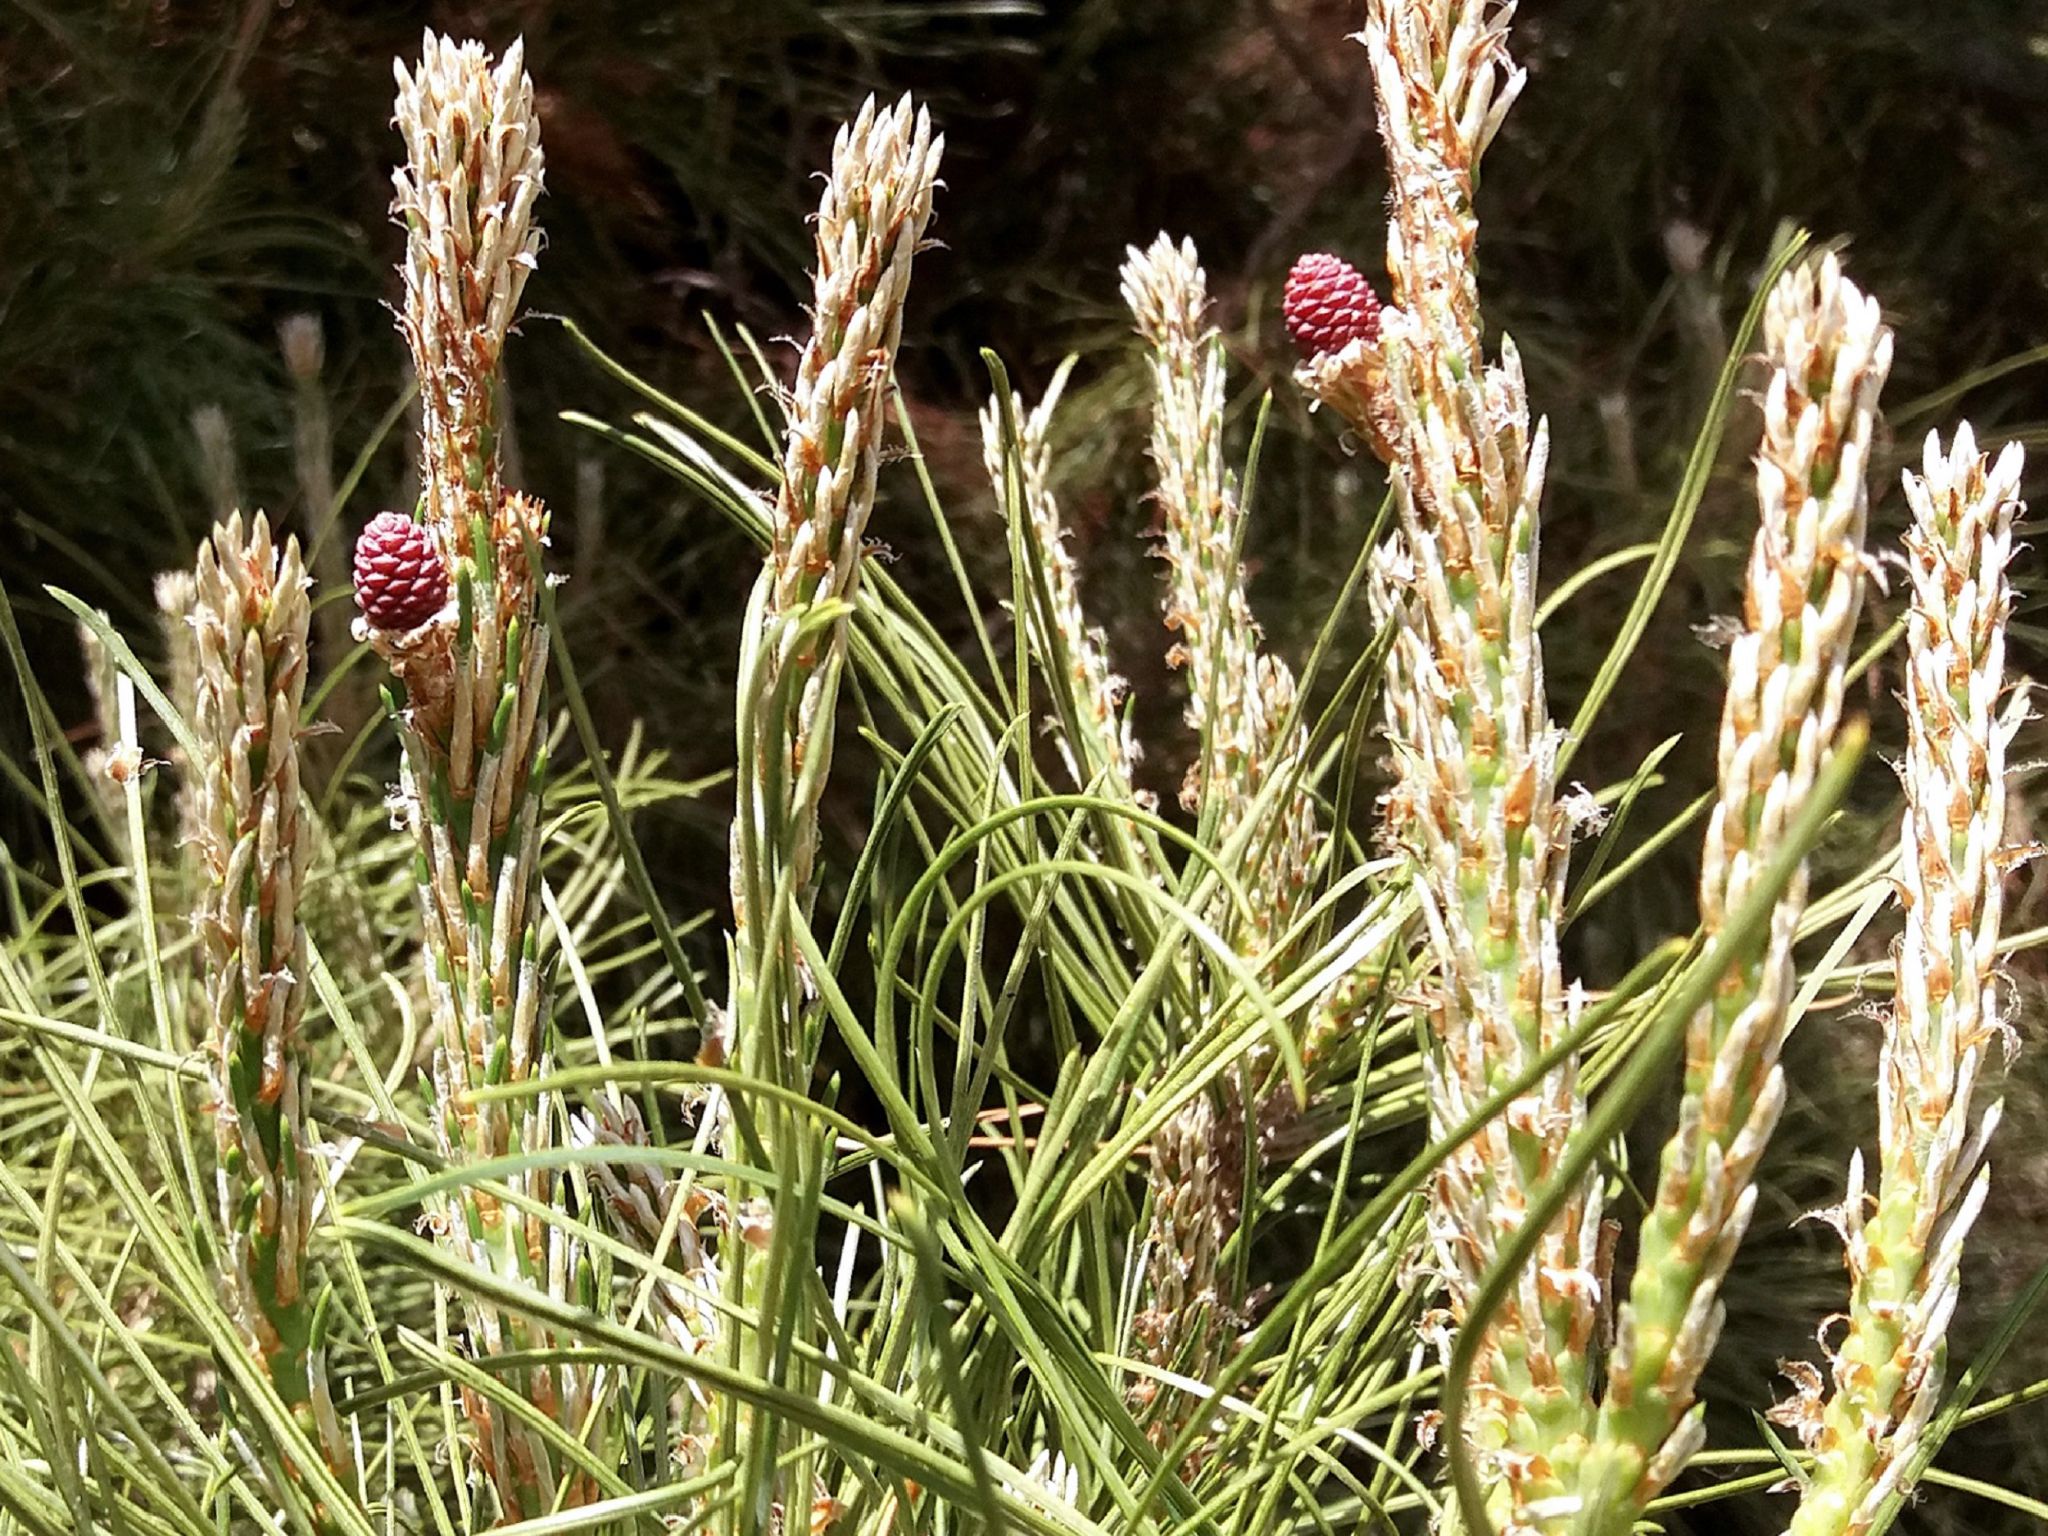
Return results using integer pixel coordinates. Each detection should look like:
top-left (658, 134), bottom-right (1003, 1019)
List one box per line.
top-left (186, 512), bottom-right (342, 1464)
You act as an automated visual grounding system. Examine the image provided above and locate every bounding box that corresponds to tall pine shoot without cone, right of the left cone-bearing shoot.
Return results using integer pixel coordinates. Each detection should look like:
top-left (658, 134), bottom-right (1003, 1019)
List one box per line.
top-left (720, 96), bottom-right (946, 1530)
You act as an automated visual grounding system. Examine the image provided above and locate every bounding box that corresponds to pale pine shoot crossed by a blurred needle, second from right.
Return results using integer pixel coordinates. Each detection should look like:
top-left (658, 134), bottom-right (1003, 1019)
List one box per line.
top-left (1581, 256), bottom-right (1892, 1536)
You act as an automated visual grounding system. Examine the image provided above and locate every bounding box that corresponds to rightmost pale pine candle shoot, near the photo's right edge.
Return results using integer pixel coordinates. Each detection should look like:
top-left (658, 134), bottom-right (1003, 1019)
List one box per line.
top-left (1772, 424), bottom-right (2025, 1536)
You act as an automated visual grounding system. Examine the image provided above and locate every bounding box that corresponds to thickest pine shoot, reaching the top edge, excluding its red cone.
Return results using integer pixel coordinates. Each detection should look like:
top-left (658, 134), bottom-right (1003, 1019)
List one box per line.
top-left (1351, 0), bottom-right (1604, 1532)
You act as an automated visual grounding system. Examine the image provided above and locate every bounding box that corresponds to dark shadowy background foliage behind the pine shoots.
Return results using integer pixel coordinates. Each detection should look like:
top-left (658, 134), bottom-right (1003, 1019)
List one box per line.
top-left (12, 0), bottom-right (2048, 1530)
